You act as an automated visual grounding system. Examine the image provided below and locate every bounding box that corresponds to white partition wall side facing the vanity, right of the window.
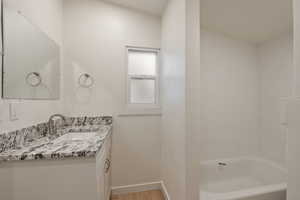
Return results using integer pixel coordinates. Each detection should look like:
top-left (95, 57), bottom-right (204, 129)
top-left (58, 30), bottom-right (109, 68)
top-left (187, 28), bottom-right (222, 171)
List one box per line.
top-left (161, 0), bottom-right (186, 200)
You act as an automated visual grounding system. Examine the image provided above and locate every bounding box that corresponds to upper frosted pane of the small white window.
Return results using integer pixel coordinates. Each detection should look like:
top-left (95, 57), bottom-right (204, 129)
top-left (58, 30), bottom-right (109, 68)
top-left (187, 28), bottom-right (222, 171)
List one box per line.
top-left (128, 50), bottom-right (157, 75)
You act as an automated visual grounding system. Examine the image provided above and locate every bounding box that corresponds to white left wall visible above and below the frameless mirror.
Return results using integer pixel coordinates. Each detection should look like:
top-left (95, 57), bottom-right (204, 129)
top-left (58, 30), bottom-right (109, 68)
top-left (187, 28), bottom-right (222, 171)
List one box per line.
top-left (0, 0), bottom-right (62, 133)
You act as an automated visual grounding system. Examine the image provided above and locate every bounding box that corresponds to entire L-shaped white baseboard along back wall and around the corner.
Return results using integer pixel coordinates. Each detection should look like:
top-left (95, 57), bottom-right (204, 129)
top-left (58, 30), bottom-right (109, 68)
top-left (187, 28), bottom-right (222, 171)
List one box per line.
top-left (111, 181), bottom-right (171, 200)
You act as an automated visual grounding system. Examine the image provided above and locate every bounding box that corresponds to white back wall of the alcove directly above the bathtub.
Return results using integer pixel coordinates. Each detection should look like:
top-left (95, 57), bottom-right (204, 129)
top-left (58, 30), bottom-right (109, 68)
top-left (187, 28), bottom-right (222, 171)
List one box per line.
top-left (200, 29), bottom-right (260, 160)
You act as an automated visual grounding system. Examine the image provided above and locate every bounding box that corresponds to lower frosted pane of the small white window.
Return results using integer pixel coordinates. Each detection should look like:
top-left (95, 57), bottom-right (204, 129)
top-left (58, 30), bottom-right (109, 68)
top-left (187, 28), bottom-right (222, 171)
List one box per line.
top-left (130, 79), bottom-right (155, 104)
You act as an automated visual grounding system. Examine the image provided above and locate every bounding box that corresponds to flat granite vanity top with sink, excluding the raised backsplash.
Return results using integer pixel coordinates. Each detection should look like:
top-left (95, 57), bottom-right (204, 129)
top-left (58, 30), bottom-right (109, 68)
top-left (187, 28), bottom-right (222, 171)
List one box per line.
top-left (0, 115), bottom-right (112, 161)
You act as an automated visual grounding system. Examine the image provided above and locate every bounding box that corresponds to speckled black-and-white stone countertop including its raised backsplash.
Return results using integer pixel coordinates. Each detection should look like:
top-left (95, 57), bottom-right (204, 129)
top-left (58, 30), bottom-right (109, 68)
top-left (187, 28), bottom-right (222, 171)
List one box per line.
top-left (0, 117), bottom-right (112, 162)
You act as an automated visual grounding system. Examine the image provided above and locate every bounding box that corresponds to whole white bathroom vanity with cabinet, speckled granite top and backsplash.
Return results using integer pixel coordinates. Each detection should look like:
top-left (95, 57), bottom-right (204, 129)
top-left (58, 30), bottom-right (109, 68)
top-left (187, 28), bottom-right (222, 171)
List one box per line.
top-left (0, 117), bottom-right (112, 200)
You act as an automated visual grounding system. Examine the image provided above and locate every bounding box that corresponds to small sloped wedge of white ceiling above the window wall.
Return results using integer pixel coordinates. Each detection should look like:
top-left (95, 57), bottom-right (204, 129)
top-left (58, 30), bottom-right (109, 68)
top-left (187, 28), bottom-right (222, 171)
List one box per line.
top-left (105, 0), bottom-right (168, 16)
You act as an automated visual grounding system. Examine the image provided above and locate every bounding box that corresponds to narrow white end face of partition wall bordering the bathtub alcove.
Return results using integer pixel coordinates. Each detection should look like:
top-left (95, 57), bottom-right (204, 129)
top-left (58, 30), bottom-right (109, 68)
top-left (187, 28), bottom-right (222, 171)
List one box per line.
top-left (185, 0), bottom-right (202, 200)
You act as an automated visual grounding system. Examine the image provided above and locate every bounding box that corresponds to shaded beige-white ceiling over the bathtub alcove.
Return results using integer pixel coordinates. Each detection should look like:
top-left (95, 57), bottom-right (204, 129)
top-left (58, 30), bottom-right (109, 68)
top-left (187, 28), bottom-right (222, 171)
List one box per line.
top-left (200, 0), bottom-right (293, 43)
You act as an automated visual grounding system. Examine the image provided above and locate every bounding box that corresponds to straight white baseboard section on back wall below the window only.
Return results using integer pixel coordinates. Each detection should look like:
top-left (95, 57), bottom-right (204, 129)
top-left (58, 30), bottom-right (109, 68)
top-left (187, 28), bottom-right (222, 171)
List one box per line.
top-left (112, 182), bottom-right (161, 195)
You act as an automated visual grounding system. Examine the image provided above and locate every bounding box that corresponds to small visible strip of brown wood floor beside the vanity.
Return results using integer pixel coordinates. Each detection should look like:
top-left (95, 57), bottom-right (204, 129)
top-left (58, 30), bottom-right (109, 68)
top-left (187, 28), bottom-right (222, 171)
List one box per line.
top-left (111, 190), bottom-right (164, 200)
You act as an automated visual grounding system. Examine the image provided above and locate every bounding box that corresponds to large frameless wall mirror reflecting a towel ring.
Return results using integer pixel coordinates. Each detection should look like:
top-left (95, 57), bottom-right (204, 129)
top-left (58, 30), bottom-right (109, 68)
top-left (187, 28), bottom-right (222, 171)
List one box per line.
top-left (2, 0), bottom-right (60, 99)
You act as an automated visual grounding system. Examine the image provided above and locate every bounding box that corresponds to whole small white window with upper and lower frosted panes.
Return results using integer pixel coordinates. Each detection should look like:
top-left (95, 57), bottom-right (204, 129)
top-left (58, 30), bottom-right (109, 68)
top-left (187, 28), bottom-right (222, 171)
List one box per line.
top-left (127, 47), bottom-right (159, 105)
